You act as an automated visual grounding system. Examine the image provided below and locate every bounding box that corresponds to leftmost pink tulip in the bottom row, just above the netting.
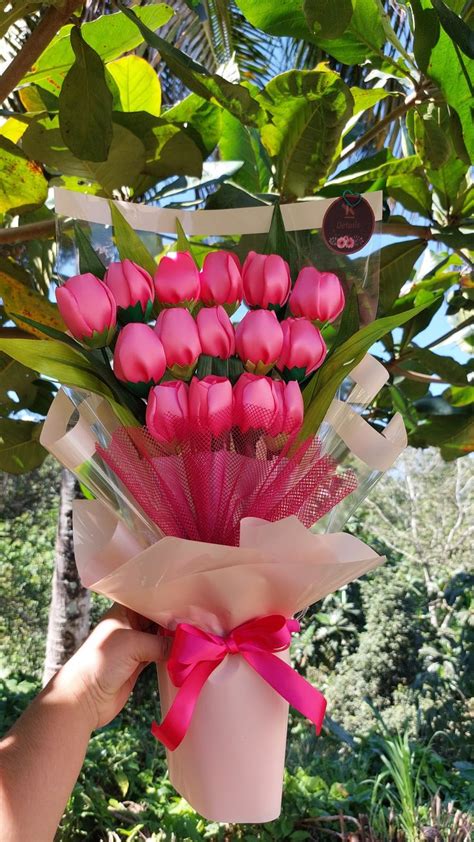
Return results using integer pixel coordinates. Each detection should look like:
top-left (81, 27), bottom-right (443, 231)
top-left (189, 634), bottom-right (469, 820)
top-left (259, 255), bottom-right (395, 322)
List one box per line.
top-left (146, 380), bottom-right (189, 444)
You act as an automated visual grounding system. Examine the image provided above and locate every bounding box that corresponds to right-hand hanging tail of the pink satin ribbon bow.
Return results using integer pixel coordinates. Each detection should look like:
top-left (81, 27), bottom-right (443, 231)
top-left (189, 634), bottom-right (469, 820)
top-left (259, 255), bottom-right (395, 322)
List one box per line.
top-left (241, 651), bottom-right (326, 734)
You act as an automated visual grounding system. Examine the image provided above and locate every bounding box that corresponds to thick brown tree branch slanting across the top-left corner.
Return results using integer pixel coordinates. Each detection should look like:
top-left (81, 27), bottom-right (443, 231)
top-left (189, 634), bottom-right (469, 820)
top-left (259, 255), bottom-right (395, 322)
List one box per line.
top-left (0, 0), bottom-right (83, 103)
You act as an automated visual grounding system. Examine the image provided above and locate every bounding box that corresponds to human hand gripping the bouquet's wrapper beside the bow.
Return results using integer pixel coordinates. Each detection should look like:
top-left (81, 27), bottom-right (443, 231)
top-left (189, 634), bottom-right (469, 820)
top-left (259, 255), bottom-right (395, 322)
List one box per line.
top-left (53, 604), bottom-right (169, 731)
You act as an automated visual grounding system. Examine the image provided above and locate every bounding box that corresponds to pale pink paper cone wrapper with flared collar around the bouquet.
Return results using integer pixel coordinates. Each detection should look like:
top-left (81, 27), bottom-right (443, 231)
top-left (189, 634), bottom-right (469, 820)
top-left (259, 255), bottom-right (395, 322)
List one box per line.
top-left (74, 500), bottom-right (383, 823)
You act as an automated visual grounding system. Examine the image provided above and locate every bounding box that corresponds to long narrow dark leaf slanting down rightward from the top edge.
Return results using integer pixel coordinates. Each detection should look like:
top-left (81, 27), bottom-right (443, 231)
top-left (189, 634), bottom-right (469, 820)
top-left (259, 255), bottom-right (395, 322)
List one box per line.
top-left (119, 3), bottom-right (263, 124)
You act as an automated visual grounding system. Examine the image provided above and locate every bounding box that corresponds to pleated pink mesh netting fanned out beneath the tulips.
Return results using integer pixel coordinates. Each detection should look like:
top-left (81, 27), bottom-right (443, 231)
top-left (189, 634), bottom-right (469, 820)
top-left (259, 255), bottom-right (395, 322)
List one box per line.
top-left (97, 409), bottom-right (357, 546)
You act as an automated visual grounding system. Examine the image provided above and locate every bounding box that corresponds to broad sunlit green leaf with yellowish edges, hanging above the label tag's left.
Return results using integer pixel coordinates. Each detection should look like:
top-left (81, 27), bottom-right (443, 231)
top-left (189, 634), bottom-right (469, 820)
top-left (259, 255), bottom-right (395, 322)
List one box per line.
top-left (259, 70), bottom-right (353, 199)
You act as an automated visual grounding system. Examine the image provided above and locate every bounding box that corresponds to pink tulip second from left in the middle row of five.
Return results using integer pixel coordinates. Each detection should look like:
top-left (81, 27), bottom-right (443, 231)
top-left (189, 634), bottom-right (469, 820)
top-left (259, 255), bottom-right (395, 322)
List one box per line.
top-left (155, 307), bottom-right (201, 380)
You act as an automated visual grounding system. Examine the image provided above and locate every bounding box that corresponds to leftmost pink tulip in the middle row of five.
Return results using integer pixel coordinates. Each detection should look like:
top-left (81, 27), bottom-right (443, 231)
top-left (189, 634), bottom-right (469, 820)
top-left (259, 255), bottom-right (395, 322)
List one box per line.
top-left (114, 322), bottom-right (166, 398)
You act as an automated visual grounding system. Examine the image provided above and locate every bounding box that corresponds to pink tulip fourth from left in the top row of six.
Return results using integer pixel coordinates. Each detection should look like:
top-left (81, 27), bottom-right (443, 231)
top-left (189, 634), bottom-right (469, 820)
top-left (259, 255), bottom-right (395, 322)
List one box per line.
top-left (201, 251), bottom-right (242, 307)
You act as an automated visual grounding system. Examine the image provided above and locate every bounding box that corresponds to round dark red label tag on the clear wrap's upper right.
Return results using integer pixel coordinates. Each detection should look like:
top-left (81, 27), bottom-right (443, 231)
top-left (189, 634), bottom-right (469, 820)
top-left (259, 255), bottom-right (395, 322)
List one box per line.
top-left (322, 190), bottom-right (375, 254)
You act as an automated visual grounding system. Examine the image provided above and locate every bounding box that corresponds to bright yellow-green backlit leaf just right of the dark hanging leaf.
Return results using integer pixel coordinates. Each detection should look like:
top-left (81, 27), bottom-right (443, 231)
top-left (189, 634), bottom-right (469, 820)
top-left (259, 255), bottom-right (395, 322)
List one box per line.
top-left (107, 55), bottom-right (161, 117)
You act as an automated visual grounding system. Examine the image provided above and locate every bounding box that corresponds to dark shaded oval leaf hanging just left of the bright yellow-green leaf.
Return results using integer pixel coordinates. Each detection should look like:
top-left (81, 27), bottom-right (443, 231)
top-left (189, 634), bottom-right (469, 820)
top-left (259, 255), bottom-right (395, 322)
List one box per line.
top-left (59, 26), bottom-right (113, 162)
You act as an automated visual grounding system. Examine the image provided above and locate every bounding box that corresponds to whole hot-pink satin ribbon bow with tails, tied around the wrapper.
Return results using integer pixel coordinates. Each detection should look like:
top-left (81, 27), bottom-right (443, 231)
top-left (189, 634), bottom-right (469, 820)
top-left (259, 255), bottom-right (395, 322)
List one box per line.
top-left (151, 614), bottom-right (326, 751)
